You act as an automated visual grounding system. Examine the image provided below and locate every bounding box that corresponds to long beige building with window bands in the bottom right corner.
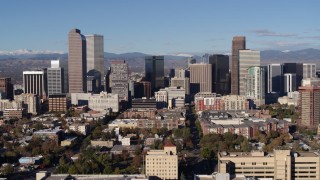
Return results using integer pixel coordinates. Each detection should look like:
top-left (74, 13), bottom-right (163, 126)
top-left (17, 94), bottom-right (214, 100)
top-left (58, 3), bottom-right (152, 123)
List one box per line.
top-left (218, 150), bottom-right (320, 180)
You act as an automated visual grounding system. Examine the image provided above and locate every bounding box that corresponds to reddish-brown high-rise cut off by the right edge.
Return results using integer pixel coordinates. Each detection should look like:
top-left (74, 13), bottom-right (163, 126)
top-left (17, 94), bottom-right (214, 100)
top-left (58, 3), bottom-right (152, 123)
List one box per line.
top-left (298, 86), bottom-right (320, 128)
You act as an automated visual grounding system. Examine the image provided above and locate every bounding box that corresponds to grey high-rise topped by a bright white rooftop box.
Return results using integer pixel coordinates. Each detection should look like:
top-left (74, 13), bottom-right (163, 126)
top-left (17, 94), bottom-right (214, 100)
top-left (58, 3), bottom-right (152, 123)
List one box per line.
top-left (46, 60), bottom-right (64, 95)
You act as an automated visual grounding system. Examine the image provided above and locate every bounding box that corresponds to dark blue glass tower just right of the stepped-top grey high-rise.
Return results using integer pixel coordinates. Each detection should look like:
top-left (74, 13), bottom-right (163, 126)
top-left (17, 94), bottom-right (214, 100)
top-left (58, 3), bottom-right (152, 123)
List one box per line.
top-left (145, 56), bottom-right (164, 95)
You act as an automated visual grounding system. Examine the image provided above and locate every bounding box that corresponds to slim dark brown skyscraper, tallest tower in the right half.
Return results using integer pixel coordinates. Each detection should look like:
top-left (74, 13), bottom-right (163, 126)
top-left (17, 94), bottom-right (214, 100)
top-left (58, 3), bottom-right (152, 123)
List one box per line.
top-left (231, 36), bottom-right (246, 95)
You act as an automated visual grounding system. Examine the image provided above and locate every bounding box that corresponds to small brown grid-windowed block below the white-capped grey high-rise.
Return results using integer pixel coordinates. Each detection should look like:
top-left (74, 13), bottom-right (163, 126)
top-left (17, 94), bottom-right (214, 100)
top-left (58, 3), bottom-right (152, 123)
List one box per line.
top-left (49, 94), bottom-right (69, 112)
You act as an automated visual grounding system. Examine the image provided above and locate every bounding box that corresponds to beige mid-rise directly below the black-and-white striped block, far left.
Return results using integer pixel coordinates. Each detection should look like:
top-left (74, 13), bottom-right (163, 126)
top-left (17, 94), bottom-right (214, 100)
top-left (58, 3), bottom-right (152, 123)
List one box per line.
top-left (14, 94), bottom-right (40, 115)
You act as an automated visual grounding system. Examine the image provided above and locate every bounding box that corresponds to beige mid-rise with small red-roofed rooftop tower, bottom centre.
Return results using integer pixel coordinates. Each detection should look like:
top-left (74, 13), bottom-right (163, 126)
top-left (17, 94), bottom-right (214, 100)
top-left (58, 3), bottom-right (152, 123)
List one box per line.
top-left (146, 142), bottom-right (178, 179)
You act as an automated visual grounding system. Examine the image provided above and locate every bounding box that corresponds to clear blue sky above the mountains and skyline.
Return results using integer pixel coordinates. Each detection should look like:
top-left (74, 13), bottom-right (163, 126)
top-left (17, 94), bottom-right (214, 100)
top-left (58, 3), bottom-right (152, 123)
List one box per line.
top-left (0, 0), bottom-right (320, 54)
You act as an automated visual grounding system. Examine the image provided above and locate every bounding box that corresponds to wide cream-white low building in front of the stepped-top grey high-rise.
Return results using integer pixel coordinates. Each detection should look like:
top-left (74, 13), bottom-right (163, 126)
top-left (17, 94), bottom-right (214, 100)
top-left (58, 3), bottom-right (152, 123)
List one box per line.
top-left (88, 92), bottom-right (119, 112)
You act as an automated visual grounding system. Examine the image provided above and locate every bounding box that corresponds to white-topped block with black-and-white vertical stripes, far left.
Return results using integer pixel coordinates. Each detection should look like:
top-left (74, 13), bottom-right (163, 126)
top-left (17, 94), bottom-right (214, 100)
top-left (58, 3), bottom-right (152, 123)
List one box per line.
top-left (23, 70), bottom-right (47, 99)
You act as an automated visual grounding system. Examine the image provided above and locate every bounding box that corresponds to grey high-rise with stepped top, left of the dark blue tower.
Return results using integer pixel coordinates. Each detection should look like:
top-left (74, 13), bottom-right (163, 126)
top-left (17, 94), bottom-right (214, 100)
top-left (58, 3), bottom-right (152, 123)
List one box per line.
top-left (110, 60), bottom-right (129, 101)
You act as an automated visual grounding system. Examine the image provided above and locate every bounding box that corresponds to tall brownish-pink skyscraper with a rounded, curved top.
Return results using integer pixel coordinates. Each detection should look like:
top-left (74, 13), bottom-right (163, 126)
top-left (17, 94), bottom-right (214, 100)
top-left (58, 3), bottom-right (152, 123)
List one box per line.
top-left (68, 29), bottom-right (87, 93)
